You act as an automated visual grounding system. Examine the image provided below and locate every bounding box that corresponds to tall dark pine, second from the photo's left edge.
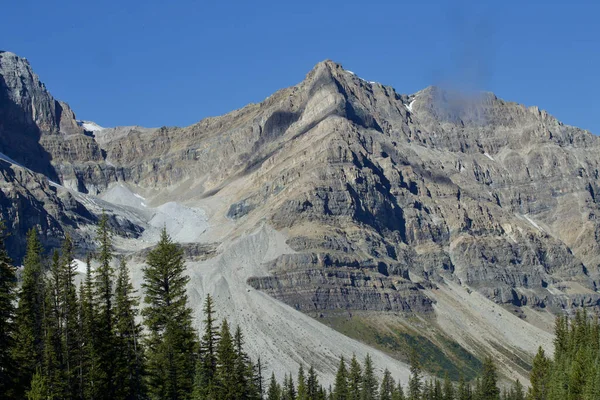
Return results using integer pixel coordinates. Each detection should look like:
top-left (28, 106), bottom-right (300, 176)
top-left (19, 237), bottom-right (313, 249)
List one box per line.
top-left (13, 228), bottom-right (44, 397)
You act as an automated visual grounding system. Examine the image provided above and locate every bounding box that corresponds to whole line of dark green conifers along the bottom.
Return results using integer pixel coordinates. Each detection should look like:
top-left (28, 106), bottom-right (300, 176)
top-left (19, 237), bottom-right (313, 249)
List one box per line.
top-left (0, 219), bottom-right (600, 400)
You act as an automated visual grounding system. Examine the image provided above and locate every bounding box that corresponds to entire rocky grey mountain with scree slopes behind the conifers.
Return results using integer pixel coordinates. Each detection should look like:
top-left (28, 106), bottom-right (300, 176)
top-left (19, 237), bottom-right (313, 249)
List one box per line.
top-left (0, 52), bottom-right (600, 379)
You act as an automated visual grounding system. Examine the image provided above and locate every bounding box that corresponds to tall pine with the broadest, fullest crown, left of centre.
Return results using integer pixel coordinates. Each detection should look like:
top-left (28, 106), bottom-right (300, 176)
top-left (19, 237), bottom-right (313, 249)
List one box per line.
top-left (142, 228), bottom-right (197, 400)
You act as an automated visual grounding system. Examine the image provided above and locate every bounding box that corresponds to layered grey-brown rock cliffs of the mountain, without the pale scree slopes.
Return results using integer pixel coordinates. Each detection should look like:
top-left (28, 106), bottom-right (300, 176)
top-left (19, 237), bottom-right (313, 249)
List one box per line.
top-left (0, 52), bottom-right (600, 378)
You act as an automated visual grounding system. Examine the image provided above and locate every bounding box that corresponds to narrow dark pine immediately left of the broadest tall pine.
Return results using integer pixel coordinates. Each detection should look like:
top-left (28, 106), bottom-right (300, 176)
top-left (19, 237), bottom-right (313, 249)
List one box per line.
top-left (114, 258), bottom-right (144, 400)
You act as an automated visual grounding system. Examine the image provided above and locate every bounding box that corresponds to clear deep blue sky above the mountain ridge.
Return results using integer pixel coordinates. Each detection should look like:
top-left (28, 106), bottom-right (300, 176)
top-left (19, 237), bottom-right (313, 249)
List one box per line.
top-left (0, 0), bottom-right (600, 134)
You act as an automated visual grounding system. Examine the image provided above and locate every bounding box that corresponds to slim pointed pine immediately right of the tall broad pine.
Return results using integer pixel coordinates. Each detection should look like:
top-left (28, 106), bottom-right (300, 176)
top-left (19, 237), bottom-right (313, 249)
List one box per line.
top-left (194, 295), bottom-right (218, 400)
